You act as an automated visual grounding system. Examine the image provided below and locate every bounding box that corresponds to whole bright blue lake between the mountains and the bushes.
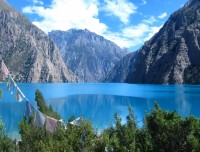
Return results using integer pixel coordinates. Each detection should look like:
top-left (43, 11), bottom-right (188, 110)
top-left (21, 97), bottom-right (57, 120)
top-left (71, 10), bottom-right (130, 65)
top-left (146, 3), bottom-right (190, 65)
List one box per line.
top-left (0, 83), bottom-right (200, 139)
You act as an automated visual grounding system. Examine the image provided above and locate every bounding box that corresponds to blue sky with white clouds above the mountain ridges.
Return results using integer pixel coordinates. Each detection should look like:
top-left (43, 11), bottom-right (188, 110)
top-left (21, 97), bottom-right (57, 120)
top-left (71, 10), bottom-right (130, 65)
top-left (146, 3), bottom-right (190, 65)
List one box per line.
top-left (7, 0), bottom-right (187, 51)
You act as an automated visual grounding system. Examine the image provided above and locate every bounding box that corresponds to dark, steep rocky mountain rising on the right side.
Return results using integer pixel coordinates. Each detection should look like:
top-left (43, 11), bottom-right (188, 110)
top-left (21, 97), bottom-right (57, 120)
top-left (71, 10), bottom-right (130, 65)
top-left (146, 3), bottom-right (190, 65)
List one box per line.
top-left (111, 0), bottom-right (200, 84)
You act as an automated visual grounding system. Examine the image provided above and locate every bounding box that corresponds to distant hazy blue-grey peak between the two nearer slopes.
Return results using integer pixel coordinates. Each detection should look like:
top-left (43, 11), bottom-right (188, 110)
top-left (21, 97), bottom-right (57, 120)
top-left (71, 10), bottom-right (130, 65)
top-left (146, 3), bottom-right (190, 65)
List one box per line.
top-left (49, 29), bottom-right (127, 82)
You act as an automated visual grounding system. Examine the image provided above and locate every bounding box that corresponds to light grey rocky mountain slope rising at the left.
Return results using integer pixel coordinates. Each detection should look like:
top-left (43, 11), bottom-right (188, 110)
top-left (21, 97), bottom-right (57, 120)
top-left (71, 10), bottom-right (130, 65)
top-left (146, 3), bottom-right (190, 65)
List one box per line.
top-left (0, 0), bottom-right (78, 82)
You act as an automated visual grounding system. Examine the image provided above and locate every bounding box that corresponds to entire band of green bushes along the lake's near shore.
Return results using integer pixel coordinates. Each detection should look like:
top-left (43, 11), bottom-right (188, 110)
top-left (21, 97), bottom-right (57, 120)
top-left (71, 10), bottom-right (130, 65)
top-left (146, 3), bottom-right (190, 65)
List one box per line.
top-left (0, 90), bottom-right (200, 152)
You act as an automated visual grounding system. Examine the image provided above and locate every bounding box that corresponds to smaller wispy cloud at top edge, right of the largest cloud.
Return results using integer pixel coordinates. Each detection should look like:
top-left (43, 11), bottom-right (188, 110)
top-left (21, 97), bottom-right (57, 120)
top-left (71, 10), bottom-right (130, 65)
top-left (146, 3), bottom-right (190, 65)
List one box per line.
top-left (103, 0), bottom-right (137, 24)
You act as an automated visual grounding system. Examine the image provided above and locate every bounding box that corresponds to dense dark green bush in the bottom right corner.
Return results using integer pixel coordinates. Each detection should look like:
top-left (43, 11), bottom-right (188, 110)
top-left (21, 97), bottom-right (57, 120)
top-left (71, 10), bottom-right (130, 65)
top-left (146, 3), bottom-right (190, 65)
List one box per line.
top-left (145, 103), bottom-right (200, 152)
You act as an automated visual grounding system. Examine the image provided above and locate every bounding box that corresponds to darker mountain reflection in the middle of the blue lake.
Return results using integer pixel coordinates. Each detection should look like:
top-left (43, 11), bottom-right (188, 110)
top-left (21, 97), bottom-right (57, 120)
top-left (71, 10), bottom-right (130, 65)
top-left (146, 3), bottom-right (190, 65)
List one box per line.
top-left (46, 95), bottom-right (147, 130)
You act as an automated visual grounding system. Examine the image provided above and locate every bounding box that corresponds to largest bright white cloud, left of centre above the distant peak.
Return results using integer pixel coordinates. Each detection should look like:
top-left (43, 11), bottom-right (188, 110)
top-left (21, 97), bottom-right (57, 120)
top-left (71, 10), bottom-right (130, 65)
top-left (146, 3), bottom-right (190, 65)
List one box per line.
top-left (22, 0), bottom-right (107, 34)
